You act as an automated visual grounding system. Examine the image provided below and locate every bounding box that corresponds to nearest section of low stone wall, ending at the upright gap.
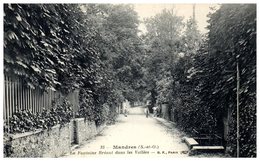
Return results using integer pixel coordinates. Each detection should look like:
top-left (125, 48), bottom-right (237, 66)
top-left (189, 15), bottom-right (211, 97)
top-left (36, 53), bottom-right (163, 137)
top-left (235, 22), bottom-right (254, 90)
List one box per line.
top-left (4, 123), bottom-right (71, 157)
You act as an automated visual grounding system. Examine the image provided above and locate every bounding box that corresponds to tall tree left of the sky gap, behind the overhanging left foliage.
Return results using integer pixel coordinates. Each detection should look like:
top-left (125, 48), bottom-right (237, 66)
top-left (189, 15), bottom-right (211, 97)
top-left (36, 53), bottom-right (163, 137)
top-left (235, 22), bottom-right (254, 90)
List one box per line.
top-left (84, 4), bottom-right (146, 104)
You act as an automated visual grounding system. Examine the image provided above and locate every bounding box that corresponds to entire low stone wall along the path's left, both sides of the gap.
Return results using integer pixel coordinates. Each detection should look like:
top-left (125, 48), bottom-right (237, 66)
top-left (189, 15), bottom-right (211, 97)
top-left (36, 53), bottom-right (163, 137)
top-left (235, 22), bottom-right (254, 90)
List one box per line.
top-left (4, 118), bottom-right (106, 158)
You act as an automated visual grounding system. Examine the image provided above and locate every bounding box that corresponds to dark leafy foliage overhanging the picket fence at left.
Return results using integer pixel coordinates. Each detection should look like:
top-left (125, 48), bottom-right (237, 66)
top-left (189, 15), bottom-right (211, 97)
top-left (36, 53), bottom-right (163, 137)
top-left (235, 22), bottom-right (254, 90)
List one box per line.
top-left (4, 4), bottom-right (107, 126)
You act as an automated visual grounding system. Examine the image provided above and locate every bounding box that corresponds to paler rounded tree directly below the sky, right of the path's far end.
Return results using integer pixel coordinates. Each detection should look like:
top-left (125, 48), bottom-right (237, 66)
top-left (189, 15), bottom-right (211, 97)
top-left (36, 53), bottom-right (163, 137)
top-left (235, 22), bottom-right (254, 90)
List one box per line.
top-left (141, 9), bottom-right (184, 105)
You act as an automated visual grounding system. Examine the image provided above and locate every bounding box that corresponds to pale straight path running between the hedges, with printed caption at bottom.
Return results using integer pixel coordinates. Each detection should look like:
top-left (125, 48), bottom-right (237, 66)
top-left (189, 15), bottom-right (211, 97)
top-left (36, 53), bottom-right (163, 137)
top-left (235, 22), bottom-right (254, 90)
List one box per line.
top-left (65, 107), bottom-right (188, 157)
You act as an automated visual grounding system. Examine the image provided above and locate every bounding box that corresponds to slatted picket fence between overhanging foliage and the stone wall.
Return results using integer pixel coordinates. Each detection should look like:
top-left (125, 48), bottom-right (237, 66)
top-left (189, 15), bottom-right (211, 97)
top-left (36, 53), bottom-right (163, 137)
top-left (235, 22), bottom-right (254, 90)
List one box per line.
top-left (3, 76), bottom-right (79, 127)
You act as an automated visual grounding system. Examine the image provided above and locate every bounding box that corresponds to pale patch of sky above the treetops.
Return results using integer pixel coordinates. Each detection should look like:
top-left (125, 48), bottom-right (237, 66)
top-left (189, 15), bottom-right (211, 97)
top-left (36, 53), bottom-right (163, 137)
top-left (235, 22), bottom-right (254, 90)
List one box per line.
top-left (134, 3), bottom-right (218, 33)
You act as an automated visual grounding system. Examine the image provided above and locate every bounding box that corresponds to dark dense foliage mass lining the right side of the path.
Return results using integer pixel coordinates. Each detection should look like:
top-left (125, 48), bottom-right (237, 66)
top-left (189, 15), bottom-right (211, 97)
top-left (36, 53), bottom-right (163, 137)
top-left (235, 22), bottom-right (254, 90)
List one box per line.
top-left (173, 5), bottom-right (256, 157)
